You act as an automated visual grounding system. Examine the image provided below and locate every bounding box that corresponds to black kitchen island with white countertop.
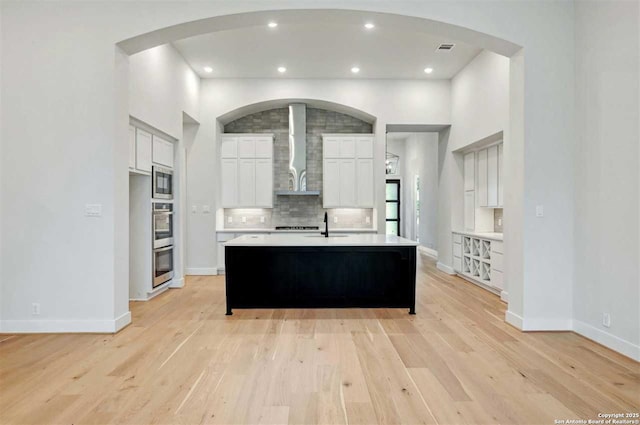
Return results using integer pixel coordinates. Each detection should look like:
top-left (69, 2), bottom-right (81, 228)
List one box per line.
top-left (224, 234), bottom-right (417, 315)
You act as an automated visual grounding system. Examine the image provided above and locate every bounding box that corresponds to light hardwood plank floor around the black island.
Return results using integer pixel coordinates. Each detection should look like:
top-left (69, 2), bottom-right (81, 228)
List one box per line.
top-left (0, 256), bottom-right (640, 424)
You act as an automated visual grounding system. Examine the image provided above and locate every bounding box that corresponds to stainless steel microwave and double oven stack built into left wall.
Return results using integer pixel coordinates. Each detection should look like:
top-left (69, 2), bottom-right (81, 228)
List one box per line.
top-left (152, 167), bottom-right (174, 288)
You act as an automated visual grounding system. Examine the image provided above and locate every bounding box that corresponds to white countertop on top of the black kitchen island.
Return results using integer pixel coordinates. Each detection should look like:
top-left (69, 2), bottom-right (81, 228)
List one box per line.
top-left (224, 234), bottom-right (418, 246)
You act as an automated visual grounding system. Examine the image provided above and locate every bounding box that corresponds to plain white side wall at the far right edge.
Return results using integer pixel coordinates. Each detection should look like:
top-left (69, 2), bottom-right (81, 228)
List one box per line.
top-left (573, 1), bottom-right (640, 360)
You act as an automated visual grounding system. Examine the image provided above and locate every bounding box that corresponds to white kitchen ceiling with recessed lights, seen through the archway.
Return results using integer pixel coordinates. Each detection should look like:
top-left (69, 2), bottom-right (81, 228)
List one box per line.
top-left (173, 21), bottom-right (481, 79)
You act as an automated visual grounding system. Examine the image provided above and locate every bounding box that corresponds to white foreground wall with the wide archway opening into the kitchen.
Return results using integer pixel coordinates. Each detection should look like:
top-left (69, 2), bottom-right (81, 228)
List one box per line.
top-left (0, 0), bottom-right (575, 342)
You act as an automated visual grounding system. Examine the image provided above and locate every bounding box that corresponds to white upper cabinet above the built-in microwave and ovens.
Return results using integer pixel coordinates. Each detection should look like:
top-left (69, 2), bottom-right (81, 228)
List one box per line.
top-left (129, 125), bottom-right (173, 174)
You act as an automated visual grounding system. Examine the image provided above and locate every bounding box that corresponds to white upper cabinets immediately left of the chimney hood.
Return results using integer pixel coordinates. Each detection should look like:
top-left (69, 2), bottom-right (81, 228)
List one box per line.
top-left (220, 134), bottom-right (273, 208)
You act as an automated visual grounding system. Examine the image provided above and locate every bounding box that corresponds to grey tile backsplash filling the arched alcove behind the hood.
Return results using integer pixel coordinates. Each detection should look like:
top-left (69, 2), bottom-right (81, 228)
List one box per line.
top-left (224, 107), bottom-right (373, 229)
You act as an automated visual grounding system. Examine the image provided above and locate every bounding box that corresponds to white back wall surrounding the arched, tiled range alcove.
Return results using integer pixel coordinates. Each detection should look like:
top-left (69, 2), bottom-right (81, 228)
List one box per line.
top-left (187, 79), bottom-right (451, 270)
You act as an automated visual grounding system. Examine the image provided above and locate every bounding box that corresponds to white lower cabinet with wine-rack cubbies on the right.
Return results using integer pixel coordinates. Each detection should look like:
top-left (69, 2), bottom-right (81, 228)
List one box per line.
top-left (453, 232), bottom-right (504, 294)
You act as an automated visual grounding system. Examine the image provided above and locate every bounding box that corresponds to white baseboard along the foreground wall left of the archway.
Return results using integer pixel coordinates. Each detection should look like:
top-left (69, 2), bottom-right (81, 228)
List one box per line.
top-left (0, 312), bottom-right (131, 333)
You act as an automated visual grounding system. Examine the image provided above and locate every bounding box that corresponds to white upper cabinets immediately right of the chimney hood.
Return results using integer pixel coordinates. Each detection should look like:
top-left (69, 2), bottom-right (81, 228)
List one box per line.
top-left (322, 134), bottom-right (374, 208)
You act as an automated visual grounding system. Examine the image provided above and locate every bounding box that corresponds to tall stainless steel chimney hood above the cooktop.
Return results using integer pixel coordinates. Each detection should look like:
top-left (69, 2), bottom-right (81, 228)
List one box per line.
top-left (276, 103), bottom-right (320, 196)
